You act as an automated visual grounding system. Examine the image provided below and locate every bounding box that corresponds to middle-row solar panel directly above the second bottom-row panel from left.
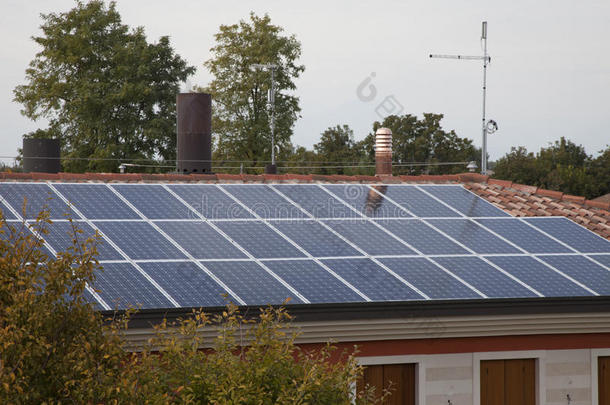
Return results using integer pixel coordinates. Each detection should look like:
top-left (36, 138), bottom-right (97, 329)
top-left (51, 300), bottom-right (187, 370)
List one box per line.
top-left (95, 221), bottom-right (186, 260)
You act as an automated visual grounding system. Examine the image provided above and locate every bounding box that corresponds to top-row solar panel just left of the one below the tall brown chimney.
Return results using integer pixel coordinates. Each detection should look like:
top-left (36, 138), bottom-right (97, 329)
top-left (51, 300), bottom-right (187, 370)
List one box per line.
top-left (112, 184), bottom-right (192, 219)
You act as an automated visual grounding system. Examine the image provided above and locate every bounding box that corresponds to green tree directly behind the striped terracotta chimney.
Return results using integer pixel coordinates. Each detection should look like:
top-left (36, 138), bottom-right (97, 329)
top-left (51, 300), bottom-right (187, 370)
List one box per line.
top-left (361, 113), bottom-right (480, 174)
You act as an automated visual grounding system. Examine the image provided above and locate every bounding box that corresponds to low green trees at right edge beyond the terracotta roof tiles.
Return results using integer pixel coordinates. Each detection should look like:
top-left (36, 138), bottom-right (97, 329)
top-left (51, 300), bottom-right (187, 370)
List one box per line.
top-left (494, 137), bottom-right (610, 198)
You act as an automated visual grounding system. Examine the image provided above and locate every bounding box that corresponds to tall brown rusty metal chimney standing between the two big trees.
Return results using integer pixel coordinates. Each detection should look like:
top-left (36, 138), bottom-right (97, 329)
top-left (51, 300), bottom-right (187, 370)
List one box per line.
top-left (176, 93), bottom-right (212, 174)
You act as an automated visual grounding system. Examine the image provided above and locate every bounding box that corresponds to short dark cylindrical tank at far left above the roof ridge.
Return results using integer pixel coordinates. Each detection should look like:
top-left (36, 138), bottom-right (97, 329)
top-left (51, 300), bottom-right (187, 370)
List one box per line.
top-left (22, 138), bottom-right (61, 173)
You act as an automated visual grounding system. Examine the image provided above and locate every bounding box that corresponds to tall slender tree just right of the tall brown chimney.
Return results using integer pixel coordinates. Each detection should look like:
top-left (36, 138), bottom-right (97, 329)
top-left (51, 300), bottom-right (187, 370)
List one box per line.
top-left (202, 13), bottom-right (305, 165)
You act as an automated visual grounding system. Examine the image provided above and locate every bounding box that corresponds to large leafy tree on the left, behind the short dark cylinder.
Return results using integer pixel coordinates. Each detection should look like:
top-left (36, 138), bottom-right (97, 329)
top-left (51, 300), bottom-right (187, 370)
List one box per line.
top-left (14, 0), bottom-right (195, 171)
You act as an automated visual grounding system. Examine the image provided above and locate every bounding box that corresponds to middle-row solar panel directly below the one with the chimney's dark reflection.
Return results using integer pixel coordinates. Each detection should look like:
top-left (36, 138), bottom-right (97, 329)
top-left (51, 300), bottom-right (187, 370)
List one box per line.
top-left (377, 219), bottom-right (468, 255)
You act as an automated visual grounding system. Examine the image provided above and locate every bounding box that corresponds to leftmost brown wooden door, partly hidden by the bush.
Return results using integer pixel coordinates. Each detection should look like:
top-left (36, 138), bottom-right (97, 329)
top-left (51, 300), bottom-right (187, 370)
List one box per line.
top-left (358, 364), bottom-right (415, 405)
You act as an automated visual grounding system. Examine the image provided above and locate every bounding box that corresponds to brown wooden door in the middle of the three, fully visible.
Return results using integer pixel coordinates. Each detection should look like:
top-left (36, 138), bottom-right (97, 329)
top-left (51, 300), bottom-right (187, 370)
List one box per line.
top-left (481, 359), bottom-right (536, 405)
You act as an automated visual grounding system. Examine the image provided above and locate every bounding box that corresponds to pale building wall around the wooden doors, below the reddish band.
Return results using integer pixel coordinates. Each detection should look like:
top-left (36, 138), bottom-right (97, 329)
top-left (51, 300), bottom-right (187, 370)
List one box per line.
top-left (359, 348), bottom-right (610, 405)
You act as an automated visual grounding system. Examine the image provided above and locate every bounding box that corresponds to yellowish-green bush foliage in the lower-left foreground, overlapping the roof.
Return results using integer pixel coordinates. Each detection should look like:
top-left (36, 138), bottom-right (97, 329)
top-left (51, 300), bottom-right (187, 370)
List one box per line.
top-left (0, 207), bottom-right (382, 405)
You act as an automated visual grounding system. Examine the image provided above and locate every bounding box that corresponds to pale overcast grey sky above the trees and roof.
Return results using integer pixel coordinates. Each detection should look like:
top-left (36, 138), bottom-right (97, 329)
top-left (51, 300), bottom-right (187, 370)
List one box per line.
top-left (0, 0), bottom-right (610, 163)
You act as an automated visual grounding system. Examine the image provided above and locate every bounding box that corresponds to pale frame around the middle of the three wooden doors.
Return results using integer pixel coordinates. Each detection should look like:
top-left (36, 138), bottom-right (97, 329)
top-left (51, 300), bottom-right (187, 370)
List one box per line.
top-left (472, 350), bottom-right (546, 405)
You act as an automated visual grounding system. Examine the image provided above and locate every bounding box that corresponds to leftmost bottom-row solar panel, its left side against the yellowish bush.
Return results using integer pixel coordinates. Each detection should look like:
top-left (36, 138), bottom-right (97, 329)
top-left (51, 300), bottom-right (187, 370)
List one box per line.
top-left (93, 263), bottom-right (173, 309)
